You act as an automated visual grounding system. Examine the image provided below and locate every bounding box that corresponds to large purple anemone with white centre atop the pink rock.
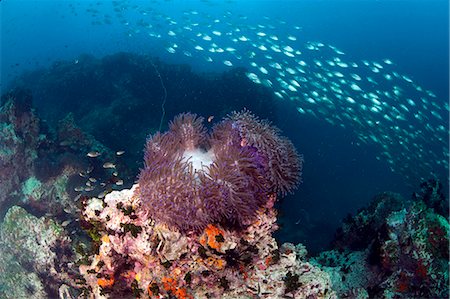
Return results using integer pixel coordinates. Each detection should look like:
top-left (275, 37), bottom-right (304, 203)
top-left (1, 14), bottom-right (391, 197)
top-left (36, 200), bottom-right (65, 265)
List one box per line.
top-left (139, 111), bottom-right (302, 232)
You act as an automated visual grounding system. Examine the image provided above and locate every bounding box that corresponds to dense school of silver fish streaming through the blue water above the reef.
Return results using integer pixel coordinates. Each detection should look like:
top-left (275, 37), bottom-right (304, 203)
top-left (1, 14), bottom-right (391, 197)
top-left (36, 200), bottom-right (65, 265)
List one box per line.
top-left (73, 1), bottom-right (449, 185)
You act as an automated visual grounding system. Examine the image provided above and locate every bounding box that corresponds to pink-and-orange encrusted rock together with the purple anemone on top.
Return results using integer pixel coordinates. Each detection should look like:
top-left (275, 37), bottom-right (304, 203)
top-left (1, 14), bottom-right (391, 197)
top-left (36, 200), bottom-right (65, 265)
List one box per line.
top-left (80, 111), bottom-right (334, 299)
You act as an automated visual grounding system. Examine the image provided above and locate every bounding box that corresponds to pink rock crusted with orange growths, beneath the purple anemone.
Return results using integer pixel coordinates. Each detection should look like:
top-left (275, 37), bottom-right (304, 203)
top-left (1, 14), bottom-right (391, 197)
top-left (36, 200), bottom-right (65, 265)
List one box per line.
top-left (80, 185), bottom-right (334, 298)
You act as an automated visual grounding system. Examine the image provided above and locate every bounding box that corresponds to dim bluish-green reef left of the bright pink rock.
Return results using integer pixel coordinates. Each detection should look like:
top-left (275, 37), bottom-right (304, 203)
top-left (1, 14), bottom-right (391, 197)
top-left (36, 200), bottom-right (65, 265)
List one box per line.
top-left (0, 88), bottom-right (126, 298)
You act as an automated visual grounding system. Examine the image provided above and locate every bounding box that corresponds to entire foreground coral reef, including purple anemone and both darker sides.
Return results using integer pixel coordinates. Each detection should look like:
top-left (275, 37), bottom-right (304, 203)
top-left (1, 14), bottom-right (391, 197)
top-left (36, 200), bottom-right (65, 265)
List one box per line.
top-left (0, 85), bottom-right (450, 299)
